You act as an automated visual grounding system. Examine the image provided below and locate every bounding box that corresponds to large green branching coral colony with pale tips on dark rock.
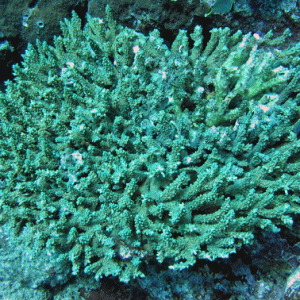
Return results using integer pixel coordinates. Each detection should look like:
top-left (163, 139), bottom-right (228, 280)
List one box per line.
top-left (0, 9), bottom-right (300, 282)
